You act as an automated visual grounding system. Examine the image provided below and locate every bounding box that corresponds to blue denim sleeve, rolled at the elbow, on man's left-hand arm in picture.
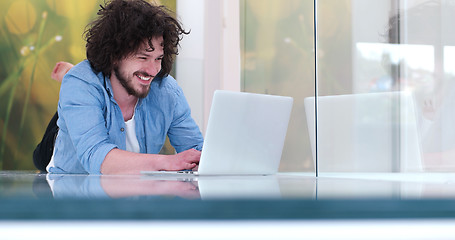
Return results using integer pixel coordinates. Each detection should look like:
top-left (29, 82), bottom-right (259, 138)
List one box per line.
top-left (58, 74), bottom-right (117, 174)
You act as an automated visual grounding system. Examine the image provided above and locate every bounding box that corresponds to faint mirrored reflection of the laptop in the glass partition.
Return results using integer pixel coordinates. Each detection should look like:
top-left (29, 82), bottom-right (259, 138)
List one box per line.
top-left (304, 92), bottom-right (422, 172)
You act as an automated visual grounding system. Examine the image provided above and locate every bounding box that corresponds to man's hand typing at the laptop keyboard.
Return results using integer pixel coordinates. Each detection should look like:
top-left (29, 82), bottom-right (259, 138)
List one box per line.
top-left (161, 149), bottom-right (201, 171)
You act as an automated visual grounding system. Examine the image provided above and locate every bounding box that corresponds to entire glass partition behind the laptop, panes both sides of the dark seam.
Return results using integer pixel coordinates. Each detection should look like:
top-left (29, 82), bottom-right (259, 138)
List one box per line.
top-left (241, 0), bottom-right (455, 173)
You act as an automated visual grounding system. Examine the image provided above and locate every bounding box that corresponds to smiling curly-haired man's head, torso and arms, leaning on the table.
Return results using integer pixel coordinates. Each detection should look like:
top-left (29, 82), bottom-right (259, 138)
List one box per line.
top-left (42, 0), bottom-right (203, 174)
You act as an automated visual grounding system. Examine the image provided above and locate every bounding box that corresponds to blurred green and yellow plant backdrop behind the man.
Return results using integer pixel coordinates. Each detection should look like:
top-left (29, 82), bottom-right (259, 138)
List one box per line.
top-left (0, 0), bottom-right (176, 170)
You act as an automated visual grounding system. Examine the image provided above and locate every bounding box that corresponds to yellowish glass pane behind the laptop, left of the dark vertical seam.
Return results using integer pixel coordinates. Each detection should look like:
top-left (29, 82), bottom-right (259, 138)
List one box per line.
top-left (240, 0), bottom-right (315, 172)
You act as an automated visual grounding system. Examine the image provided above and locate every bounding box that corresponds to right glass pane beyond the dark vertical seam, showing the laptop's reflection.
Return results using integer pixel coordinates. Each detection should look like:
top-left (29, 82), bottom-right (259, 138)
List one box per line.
top-left (313, 0), bottom-right (455, 173)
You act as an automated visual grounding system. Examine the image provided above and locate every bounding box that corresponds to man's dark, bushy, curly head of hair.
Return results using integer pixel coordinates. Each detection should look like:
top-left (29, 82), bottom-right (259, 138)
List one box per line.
top-left (84, 0), bottom-right (189, 77)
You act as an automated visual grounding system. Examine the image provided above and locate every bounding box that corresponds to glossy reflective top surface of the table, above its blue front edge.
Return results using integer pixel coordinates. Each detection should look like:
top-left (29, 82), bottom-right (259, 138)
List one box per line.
top-left (0, 172), bottom-right (455, 201)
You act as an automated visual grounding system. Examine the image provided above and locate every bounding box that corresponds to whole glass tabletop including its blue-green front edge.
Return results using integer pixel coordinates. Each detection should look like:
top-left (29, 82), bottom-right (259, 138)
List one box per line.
top-left (0, 171), bottom-right (455, 220)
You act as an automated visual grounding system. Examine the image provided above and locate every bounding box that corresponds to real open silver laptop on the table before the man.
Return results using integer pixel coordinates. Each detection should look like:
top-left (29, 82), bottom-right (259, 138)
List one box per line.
top-left (142, 90), bottom-right (293, 175)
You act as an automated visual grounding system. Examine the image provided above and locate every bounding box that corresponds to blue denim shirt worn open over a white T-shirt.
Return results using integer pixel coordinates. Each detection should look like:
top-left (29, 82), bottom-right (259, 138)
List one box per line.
top-left (49, 60), bottom-right (203, 174)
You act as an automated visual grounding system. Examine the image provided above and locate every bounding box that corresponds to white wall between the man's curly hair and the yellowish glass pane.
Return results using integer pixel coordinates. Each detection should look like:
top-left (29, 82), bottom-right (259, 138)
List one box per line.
top-left (176, 0), bottom-right (240, 133)
